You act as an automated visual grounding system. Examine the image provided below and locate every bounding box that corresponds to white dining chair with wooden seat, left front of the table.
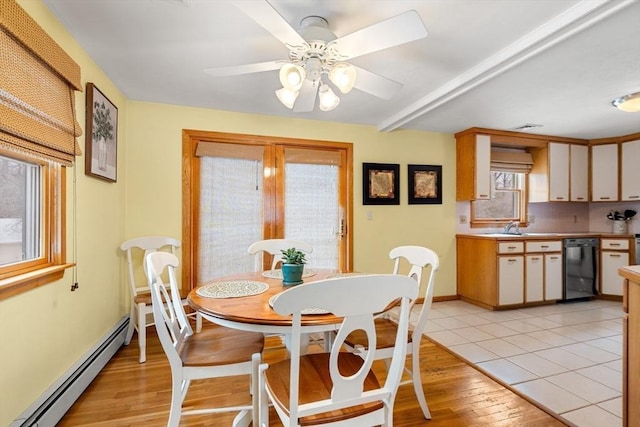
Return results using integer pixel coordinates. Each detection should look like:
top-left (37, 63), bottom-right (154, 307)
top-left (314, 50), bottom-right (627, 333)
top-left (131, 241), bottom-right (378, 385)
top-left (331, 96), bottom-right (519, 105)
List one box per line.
top-left (145, 252), bottom-right (264, 427)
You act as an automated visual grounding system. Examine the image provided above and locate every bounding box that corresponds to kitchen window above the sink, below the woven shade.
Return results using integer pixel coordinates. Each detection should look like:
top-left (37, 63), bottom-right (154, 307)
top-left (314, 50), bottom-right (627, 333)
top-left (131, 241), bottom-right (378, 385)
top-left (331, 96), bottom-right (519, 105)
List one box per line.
top-left (471, 171), bottom-right (526, 226)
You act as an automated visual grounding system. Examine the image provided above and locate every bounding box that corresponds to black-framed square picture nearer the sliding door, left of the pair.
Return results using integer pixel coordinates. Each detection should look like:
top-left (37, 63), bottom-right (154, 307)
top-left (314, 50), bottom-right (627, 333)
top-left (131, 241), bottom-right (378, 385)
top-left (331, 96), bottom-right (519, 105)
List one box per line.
top-left (362, 163), bottom-right (400, 205)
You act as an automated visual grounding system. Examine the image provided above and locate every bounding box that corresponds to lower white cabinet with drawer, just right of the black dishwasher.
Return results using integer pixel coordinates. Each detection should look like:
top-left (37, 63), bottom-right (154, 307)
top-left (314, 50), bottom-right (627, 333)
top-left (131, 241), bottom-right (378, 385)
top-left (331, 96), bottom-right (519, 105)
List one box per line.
top-left (600, 238), bottom-right (630, 296)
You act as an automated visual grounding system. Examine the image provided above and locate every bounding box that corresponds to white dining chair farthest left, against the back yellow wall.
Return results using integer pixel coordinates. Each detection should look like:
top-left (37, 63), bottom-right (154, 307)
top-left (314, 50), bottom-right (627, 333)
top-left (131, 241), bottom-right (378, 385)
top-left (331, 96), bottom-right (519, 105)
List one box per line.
top-left (120, 236), bottom-right (202, 363)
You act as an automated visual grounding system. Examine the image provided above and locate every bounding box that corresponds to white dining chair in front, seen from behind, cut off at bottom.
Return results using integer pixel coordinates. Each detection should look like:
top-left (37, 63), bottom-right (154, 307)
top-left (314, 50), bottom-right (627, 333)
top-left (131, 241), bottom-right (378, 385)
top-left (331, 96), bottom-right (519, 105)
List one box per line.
top-left (259, 274), bottom-right (418, 427)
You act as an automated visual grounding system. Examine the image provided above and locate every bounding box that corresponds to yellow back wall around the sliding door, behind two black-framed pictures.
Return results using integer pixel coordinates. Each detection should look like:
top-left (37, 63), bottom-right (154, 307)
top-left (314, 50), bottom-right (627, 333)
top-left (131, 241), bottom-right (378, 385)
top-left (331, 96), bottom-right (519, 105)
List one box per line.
top-left (125, 101), bottom-right (456, 295)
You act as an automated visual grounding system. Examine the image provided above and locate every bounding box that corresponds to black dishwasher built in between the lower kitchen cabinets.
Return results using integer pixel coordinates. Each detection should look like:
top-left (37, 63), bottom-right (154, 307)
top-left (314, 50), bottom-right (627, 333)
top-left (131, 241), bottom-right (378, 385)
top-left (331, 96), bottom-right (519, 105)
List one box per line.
top-left (562, 238), bottom-right (598, 301)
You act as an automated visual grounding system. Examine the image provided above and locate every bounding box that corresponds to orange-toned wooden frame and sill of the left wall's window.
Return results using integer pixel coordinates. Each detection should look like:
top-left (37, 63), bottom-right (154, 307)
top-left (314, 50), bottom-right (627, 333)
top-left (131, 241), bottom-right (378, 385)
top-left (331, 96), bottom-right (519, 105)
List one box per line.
top-left (0, 148), bottom-right (74, 300)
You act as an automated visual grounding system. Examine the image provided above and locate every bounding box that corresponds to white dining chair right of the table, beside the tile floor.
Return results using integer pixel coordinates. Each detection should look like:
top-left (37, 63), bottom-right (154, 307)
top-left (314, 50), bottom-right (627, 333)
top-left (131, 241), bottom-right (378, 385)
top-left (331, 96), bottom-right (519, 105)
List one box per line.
top-left (345, 246), bottom-right (440, 420)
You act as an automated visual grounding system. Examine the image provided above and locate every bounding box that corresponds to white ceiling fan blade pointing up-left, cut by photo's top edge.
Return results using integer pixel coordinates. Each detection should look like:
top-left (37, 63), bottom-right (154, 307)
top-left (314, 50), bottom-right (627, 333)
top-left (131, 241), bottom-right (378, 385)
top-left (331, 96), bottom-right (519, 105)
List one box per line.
top-left (233, 0), bottom-right (305, 46)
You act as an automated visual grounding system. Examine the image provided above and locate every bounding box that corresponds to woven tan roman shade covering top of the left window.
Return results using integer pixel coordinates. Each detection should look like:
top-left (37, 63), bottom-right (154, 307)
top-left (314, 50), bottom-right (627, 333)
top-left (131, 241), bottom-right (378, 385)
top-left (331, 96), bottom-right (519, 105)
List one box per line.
top-left (0, 0), bottom-right (82, 166)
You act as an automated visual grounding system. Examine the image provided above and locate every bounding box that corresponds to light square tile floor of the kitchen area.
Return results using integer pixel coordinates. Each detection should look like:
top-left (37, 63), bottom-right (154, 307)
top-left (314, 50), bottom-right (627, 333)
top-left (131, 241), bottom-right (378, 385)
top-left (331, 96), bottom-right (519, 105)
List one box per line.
top-left (425, 300), bottom-right (623, 427)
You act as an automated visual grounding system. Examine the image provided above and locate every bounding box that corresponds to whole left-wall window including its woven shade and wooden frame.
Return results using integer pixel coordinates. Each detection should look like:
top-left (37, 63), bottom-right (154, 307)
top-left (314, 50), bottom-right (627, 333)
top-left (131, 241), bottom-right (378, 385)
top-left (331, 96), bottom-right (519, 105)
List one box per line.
top-left (0, 2), bottom-right (82, 299)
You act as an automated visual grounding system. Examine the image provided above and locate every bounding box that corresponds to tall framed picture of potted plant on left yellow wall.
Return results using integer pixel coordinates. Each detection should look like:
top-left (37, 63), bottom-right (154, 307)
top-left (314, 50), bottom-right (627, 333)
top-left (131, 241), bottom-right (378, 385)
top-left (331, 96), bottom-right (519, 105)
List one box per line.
top-left (84, 83), bottom-right (118, 182)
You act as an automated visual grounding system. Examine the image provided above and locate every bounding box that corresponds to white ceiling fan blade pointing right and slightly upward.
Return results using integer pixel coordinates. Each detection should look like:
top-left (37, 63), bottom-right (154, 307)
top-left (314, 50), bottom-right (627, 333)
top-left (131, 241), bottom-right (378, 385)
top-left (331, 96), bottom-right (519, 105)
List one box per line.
top-left (334, 10), bottom-right (428, 59)
